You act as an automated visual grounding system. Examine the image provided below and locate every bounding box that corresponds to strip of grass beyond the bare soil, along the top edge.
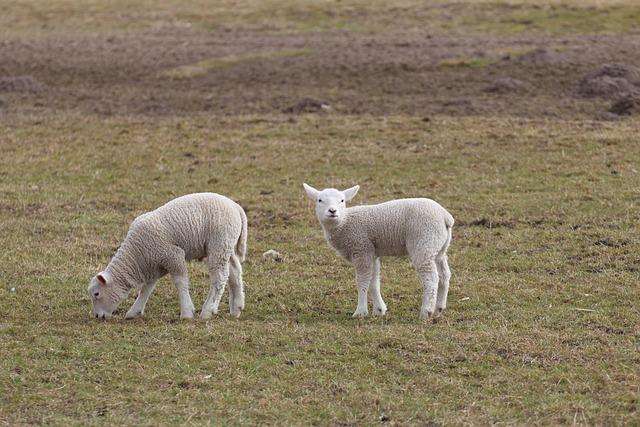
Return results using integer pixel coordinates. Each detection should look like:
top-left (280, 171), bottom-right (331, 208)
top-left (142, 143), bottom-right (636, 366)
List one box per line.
top-left (0, 0), bottom-right (640, 37)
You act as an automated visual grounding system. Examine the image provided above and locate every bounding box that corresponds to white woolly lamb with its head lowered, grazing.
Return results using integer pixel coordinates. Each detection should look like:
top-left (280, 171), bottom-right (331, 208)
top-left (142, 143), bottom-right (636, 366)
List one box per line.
top-left (88, 193), bottom-right (247, 319)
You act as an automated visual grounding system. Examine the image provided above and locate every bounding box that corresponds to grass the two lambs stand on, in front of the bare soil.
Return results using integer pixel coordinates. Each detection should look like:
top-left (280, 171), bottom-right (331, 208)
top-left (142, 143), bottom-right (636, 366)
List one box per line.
top-left (0, 114), bottom-right (640, 425)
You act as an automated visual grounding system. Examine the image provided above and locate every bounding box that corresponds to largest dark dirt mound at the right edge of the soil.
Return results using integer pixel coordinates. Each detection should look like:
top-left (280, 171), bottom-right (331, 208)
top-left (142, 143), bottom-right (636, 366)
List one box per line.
top-left (578, 64), bottom-right (640, 99)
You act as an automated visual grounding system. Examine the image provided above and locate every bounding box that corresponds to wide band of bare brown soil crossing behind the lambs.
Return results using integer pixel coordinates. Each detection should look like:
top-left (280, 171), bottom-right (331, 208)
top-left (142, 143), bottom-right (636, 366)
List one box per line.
top-left (0, 29), bottom-right (640, 118)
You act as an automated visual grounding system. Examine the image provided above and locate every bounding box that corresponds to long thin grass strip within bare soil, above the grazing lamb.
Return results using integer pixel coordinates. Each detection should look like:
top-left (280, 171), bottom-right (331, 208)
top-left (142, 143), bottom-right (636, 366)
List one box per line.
top-left (161, 49), bottom-right (311, 79)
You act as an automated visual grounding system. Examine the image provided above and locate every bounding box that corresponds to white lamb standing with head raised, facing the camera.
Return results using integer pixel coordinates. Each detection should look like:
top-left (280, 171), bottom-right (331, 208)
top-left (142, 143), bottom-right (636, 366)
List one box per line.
top-left (303, 184), bottom-right (453, 319)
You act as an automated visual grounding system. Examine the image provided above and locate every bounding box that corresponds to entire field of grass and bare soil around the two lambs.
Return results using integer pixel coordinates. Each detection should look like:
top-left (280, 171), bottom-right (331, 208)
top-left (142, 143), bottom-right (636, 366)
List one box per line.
top-left (0, 0), bottom-right (640, 427)
